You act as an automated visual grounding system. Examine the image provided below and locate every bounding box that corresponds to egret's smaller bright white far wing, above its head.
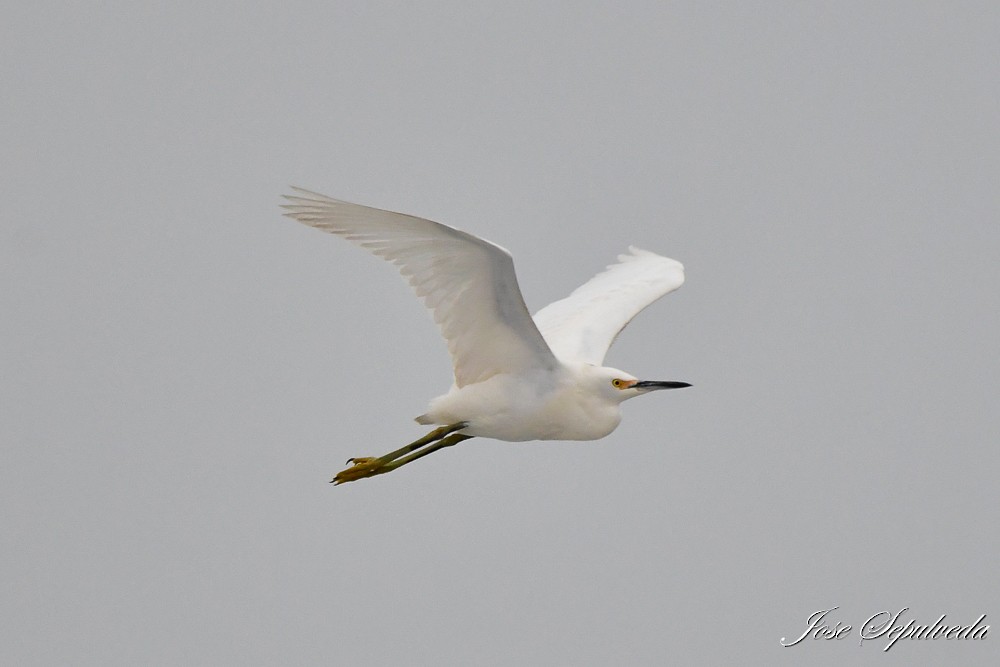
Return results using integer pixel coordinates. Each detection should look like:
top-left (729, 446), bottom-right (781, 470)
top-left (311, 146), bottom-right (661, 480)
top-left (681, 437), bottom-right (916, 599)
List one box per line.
top-left (535, 247), bottom-right (684, 366)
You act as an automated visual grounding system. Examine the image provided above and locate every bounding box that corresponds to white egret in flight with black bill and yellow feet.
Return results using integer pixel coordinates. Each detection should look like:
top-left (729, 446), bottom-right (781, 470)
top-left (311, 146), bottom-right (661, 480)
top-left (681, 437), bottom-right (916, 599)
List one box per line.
top-left (283, 188), bottom-right (691, 484)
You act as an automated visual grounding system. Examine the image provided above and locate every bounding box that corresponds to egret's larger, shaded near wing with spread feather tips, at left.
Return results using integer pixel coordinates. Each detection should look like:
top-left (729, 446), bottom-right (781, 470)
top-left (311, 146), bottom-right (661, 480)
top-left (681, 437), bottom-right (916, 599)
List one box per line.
top-left (283, 188), bottom-right (558, 387)
